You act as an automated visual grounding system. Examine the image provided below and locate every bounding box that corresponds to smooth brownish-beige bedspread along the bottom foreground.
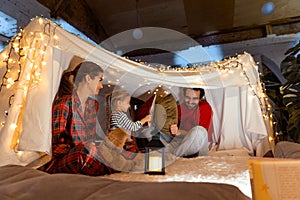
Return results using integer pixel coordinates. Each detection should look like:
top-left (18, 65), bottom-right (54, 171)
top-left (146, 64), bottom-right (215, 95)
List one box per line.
top-left (0, 165), bottom-right (249, 200)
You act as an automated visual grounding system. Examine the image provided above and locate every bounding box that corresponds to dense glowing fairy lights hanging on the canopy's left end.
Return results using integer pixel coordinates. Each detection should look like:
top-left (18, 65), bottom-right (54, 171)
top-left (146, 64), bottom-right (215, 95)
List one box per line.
top-left (0, 18), bottom-right (58, 150)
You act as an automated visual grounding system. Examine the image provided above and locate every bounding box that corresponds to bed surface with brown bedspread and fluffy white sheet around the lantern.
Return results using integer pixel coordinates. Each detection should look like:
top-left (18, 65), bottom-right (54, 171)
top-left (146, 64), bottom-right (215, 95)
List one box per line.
top-left (0, 151), bottom-right (251, 200)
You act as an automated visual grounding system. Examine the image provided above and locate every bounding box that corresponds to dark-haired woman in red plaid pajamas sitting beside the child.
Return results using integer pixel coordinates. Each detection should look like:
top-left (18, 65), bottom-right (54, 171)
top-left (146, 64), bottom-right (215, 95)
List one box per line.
top-left (45, 61), bottom-right (134, 176)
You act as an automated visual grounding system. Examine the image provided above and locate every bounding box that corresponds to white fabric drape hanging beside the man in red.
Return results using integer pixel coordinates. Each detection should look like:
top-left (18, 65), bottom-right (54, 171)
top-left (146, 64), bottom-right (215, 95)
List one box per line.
top-left (206, 86), bottom-right (267, 153)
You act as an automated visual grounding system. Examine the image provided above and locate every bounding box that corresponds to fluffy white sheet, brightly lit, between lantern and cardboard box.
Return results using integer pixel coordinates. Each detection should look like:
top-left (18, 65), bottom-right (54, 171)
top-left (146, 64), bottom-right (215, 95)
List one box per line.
top-left (106, 153), bottom-right (252, 198)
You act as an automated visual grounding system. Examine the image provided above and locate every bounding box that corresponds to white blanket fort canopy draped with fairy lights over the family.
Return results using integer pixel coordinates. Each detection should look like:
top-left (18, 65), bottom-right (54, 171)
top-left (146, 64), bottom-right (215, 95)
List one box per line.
top-left (0, 18), bottom-right (272, 166)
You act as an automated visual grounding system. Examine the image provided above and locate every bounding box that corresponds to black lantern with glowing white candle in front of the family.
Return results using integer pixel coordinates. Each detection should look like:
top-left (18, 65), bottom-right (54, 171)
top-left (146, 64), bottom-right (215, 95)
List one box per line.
top-left (145, 132), bottom-right (165, 175)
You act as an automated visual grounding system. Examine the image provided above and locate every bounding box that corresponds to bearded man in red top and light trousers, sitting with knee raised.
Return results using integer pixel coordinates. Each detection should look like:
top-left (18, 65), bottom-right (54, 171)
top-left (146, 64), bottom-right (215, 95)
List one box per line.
top-left (166, 88), bottom-right (212, 157)
